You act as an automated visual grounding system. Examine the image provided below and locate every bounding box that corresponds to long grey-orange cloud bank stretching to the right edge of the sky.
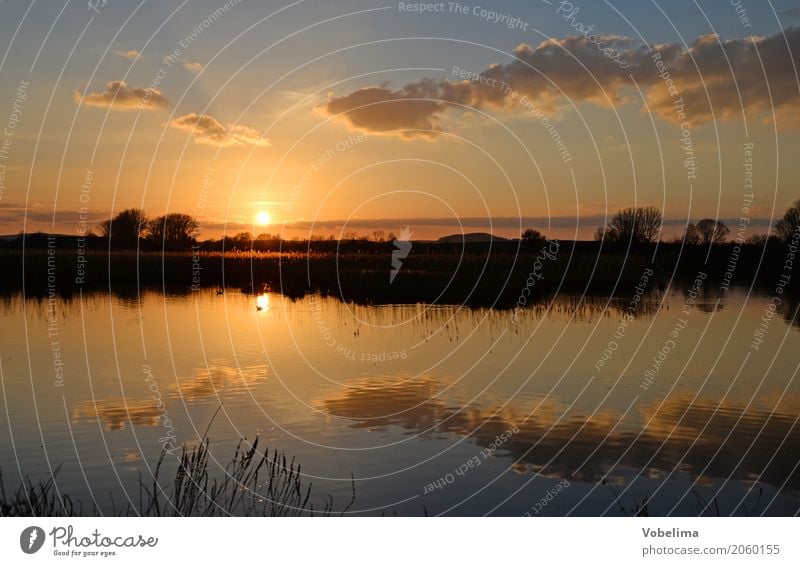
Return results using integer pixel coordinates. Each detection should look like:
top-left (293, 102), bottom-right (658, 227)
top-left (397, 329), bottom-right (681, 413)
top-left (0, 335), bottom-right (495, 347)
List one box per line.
top-left (324, 27), bottom-right (800, 138)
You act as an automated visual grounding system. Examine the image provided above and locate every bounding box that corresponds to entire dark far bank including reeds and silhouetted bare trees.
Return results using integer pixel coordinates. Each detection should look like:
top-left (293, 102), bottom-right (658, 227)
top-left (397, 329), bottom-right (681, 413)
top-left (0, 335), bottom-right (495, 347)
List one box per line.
top-left (0, 201), bottom-right (800, 307)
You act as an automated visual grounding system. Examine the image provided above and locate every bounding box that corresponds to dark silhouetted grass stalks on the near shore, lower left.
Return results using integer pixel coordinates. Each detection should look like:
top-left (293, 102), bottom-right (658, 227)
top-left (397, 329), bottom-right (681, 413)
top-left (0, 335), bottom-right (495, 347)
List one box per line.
top-left (0, 436), bottom-right (355, 517)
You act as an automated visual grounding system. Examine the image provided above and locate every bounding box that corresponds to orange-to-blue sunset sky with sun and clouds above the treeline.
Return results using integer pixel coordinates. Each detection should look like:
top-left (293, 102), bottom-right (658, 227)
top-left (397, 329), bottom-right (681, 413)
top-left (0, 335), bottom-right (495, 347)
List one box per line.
top-left (0, 0), bottom-right (800, 239)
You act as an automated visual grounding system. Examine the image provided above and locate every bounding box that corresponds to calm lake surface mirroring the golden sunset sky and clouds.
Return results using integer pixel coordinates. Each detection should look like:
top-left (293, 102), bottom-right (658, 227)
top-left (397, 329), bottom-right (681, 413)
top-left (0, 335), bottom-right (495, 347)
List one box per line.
top-left (0, 288), bottom-right (800, 513)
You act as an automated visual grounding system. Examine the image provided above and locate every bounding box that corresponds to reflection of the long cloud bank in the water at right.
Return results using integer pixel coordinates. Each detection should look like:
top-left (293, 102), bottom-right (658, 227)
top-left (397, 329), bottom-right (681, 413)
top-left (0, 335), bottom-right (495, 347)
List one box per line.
top-left (317, 379), bottom-right (800, 490)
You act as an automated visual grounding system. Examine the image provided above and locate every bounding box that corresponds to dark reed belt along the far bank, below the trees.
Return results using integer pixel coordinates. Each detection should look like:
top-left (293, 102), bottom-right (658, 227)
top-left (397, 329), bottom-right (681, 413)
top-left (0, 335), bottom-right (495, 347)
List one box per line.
top-left (0, 236), bottom-right (800, 307)
